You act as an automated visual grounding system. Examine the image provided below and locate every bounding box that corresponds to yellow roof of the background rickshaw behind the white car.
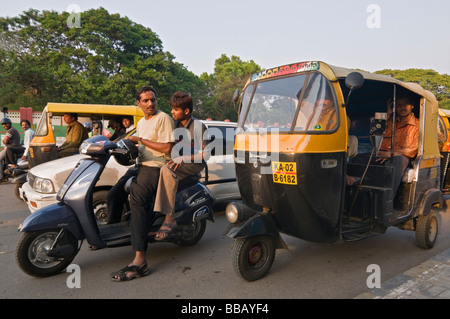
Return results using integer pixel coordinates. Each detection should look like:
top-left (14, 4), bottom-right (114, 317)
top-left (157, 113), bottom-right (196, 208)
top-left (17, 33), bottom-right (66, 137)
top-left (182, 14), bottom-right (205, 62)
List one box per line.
top-left (46, 103), bottom-right (144, 116)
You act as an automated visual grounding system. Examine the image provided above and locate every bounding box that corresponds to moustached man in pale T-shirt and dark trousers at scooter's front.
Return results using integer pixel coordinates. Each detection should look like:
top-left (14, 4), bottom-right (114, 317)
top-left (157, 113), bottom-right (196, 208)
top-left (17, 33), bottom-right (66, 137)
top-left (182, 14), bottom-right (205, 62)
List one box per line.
top-left (111, 86), bottom-right (175, 281)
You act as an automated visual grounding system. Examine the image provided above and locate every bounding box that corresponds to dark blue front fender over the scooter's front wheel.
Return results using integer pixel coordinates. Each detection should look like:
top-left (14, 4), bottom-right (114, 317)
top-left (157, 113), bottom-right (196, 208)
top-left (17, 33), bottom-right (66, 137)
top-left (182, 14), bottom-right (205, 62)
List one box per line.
top-left (19, 203), bottom-right (85, 240)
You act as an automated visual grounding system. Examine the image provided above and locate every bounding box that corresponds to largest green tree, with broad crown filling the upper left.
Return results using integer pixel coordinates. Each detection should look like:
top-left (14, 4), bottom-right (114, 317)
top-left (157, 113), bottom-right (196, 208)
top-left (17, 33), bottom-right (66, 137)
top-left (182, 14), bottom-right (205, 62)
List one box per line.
top-left (0, 8), bottom-right (202, 111)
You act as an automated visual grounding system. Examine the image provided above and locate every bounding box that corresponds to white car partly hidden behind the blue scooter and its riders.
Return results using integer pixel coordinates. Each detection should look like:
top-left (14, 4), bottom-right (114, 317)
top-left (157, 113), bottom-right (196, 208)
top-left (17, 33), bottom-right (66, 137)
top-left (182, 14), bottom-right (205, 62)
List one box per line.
top-left (20, 121), bottom-right (241, 220)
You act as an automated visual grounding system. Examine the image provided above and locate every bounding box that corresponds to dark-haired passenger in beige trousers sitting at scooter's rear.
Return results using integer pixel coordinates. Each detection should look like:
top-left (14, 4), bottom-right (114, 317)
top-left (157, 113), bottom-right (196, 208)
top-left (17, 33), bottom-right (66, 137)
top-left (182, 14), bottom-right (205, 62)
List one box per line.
top-left (154, 92), bottom-right (210, 240)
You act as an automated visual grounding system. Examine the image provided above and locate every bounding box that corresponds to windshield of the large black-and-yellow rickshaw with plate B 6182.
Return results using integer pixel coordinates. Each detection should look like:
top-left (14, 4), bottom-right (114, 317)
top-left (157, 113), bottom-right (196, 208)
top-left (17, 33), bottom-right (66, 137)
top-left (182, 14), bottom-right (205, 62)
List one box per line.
top-left (239, 73), bottom-right (337, 133)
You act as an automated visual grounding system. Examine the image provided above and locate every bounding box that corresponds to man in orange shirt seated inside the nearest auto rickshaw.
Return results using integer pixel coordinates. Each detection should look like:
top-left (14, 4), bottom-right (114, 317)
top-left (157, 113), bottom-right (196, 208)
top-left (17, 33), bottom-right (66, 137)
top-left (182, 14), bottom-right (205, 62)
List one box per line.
top-left (376, 96), bottom-right (419, 197)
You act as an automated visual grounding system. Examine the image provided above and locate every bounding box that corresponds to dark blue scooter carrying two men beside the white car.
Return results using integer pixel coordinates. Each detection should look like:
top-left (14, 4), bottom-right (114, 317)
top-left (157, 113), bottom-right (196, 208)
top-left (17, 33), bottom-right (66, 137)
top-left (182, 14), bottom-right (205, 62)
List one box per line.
top-left (16, 136), bottom-right (214, 277)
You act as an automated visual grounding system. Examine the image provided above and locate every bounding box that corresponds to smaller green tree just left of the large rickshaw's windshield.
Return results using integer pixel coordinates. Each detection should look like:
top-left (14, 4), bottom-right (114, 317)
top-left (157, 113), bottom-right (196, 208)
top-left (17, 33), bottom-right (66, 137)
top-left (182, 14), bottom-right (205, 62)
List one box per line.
top-left (200, 54), bottom-right (261, 121)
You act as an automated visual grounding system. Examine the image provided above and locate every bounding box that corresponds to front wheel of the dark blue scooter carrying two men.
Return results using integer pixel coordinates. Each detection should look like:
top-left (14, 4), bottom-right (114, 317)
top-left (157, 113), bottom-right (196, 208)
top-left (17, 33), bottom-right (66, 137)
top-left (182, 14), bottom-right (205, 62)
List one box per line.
top-left (16, 229), bottom-right (78, 277)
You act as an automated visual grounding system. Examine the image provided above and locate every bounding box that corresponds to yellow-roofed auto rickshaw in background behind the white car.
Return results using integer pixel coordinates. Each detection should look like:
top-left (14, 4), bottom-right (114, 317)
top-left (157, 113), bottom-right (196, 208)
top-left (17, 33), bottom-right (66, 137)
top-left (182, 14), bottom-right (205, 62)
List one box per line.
top-left (29, 103), bottom-right (144, 168)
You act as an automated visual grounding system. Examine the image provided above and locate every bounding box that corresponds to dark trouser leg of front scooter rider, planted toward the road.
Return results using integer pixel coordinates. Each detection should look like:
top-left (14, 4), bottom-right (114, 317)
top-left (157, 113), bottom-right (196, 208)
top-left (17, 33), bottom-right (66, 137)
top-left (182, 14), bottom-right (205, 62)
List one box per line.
top-left (130, 166), bottom-right (160, 252)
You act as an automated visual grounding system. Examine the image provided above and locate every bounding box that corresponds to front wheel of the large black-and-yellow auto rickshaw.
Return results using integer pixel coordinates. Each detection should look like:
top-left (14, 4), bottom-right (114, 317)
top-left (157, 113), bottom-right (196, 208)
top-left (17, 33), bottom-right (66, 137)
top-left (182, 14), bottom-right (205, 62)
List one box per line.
top-left (232, 235), bottom-right (276, 281)
